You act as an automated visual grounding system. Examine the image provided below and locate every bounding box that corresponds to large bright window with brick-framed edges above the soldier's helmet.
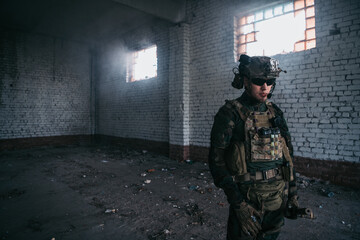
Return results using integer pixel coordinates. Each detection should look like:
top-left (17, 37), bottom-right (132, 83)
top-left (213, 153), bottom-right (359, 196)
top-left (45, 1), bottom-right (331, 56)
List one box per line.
top-left (236, 0), bottom-right (316, 56)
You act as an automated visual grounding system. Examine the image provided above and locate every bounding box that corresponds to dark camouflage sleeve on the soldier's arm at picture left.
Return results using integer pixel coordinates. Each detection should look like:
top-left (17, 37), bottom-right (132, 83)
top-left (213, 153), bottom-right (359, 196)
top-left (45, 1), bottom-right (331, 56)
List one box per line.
top-left (209, 105), bottom-right (243, 204)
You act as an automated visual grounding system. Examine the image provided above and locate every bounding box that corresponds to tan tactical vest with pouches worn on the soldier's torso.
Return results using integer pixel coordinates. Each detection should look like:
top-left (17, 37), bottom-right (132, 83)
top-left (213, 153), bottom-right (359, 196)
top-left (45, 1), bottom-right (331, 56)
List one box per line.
top-left (227, 100), bottom-right (293, 182)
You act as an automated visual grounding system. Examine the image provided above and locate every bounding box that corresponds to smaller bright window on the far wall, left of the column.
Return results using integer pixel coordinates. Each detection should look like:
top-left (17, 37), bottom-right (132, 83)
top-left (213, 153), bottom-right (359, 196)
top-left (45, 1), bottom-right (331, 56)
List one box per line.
top-left (126, 45), bottom-right (157, 82)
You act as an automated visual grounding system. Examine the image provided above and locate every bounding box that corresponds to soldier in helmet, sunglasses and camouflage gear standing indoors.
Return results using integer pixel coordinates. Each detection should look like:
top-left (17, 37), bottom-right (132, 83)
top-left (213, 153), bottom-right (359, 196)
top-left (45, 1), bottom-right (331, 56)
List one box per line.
top-left (209, 54), bottom-right (298, 240)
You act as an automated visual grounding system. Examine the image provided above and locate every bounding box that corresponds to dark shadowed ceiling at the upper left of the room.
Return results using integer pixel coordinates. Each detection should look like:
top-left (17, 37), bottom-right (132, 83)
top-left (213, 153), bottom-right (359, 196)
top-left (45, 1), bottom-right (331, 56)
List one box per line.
top-left (0, 0), bottom-right (186, 43)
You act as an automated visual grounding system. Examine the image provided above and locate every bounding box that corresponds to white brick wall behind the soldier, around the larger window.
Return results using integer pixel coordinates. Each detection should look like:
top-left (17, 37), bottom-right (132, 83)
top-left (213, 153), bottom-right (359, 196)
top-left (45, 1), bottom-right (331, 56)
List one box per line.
top-left (188, 0), bottom-right (360, 163)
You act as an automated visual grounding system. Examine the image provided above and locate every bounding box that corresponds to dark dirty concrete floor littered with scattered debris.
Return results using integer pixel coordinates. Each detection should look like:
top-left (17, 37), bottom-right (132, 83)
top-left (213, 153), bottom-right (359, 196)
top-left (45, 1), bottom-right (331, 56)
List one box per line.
top-left (0, 143), bottom-right (360, 240)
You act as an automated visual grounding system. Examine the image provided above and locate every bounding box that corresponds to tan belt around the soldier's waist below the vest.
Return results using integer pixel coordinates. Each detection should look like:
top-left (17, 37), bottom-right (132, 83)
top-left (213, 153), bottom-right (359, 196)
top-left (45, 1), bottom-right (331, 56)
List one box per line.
top-left (232, 168), bottom-right (283, 182)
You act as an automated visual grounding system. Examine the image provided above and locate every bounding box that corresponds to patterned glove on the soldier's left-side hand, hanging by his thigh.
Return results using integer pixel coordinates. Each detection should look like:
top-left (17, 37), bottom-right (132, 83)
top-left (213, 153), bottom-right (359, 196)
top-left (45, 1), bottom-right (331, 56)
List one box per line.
top-left (234, 202), bottom-right (261, 237)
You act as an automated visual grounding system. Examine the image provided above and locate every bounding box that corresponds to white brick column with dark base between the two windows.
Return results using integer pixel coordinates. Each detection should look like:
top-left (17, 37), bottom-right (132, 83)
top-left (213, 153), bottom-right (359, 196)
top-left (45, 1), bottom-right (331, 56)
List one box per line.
top-left (169, 23), bottom-right (190, 161)
